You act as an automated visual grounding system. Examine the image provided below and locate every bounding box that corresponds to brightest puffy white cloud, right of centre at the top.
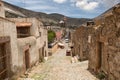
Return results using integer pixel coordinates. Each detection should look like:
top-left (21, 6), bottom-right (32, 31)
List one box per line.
top-left (76, 0), bottom-right (99, 11)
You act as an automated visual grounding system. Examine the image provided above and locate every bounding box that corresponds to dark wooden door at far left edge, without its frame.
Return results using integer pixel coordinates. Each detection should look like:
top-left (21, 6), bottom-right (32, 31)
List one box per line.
top-left (0, 43), bottom-right (10, 80)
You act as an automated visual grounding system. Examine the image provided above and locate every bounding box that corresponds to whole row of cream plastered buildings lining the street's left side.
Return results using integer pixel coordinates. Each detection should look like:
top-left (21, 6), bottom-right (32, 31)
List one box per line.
top-left (0, 1), bottom-right (48, 80)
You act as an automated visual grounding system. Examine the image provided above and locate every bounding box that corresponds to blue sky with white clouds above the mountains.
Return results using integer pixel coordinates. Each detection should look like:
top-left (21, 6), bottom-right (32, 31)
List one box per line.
top-left (4, 0), bottom-right (120, 18)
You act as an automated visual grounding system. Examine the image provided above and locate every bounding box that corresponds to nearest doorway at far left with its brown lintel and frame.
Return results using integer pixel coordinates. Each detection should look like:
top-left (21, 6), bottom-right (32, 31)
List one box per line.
top-left (0, 37), bottom-right (10, 80)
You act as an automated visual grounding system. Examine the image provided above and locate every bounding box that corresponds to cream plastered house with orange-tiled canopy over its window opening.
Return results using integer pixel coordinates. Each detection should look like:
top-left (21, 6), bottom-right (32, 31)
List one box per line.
top-left (8, 18), bottom-right (48, 71)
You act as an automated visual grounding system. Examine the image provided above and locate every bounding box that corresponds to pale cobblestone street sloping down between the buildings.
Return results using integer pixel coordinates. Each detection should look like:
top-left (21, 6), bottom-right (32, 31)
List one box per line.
top-left (20, 44), bottom-right (98, 80)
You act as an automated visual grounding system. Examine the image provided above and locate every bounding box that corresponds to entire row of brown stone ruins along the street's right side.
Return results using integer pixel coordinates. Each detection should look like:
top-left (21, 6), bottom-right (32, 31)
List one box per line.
top-left (73, 4), bottom-right (120, 80)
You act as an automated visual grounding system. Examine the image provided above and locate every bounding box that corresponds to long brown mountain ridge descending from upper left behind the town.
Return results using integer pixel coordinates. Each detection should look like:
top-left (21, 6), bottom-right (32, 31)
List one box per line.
top-left (3, 1), bottom-right (91, 26)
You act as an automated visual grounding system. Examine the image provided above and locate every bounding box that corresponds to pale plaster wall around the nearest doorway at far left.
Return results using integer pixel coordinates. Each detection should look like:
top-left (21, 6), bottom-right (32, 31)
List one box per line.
top-left (0, 17), bottom-right (19, 76)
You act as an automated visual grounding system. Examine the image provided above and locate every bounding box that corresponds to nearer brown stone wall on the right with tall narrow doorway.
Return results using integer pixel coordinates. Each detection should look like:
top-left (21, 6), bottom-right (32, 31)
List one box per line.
top-left (89, 5), bottom-right (120, 80)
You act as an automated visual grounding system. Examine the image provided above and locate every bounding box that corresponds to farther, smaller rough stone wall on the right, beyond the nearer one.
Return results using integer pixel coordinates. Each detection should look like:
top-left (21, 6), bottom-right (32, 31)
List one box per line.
top-left (72, 26), bottom-right (92, 61)
